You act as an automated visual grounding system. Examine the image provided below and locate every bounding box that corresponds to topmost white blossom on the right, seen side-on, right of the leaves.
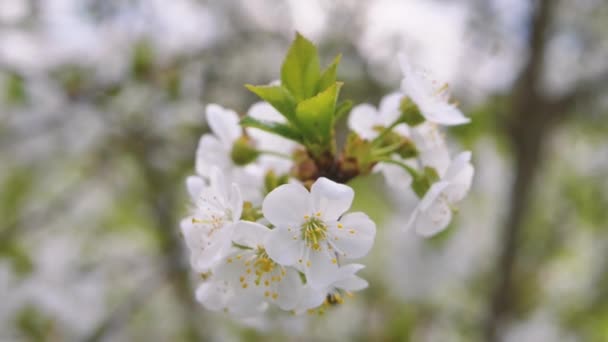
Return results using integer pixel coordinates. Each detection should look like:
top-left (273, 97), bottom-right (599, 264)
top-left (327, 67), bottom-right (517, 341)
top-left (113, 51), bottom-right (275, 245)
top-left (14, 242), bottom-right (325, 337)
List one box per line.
top-left (399, 54), bottom-right (470, 125)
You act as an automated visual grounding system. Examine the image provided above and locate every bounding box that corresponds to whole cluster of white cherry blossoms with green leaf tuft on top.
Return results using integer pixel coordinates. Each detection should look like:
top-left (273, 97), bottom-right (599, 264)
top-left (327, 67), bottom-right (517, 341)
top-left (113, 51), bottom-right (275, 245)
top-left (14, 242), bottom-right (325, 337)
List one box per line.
top-left (181, 35), bottom-right (473, 318)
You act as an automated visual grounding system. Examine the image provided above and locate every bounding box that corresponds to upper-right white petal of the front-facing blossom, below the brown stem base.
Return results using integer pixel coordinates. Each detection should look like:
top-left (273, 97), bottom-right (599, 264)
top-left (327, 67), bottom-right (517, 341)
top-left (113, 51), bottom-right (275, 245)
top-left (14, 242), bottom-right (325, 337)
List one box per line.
top-left (310, 177), bottom-right (355, 220)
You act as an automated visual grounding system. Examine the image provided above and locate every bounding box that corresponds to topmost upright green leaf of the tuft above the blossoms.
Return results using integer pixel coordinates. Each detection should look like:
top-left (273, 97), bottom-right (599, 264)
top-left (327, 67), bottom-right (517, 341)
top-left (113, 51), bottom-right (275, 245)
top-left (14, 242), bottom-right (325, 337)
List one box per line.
top-left (281, 33), bottom-right (321, 102)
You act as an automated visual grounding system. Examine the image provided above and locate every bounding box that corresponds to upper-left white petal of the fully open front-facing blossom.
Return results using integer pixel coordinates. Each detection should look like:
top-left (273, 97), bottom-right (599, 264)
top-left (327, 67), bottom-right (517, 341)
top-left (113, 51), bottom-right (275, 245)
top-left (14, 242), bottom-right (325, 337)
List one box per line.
top-left (262, 183), bottom-right (312, 228)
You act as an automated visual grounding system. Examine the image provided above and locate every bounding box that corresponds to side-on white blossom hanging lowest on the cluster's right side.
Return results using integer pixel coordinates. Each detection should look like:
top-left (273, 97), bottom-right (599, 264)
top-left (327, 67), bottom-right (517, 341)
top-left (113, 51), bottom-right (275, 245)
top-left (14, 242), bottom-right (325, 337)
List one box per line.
top-left (406, 151), bottom-right (474, 237)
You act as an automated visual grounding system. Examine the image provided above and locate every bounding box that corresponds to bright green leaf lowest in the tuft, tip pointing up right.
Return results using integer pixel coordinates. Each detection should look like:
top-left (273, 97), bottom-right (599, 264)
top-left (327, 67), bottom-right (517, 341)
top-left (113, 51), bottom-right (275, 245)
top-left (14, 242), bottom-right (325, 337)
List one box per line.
top-left (296, 82), bottom-right (342, 145)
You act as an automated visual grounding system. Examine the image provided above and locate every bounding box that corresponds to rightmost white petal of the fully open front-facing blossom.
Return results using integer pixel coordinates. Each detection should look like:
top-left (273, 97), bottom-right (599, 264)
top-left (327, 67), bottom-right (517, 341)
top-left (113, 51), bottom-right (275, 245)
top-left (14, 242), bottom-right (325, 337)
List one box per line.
top-left (328, 212), bottom-right (376, 259)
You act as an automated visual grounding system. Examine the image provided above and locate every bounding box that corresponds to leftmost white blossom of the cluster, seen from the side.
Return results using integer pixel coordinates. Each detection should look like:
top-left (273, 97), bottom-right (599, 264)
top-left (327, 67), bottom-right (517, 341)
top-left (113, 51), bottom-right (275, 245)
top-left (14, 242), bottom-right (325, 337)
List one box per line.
top-left (181, 168), bottom-right (243, 272)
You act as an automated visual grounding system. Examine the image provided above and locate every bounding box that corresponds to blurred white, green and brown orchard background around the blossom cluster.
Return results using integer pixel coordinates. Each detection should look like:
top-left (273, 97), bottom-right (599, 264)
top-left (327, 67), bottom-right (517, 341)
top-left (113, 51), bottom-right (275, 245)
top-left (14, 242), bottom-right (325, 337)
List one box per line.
top-left (0, 0), bottom-right (608, 342)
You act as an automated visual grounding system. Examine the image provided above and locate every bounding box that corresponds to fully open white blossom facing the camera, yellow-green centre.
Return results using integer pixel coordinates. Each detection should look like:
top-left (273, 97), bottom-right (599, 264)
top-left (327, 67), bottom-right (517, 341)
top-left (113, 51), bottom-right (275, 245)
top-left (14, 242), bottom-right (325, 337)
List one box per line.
top-left (262, 177), bottom-right (376, 288)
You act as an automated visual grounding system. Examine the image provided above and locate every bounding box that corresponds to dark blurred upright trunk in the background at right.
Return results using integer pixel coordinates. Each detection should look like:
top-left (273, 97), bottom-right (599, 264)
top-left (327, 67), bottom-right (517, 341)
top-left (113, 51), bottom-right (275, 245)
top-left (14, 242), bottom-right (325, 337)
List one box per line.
top-left (484, 0), bottom-right (555, 341)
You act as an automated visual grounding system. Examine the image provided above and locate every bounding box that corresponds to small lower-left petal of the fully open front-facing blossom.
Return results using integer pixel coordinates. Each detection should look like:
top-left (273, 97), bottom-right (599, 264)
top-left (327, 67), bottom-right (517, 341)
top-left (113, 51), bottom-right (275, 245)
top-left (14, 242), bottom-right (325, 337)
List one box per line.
top-left (264, 228), bottom-right (304, 266)
